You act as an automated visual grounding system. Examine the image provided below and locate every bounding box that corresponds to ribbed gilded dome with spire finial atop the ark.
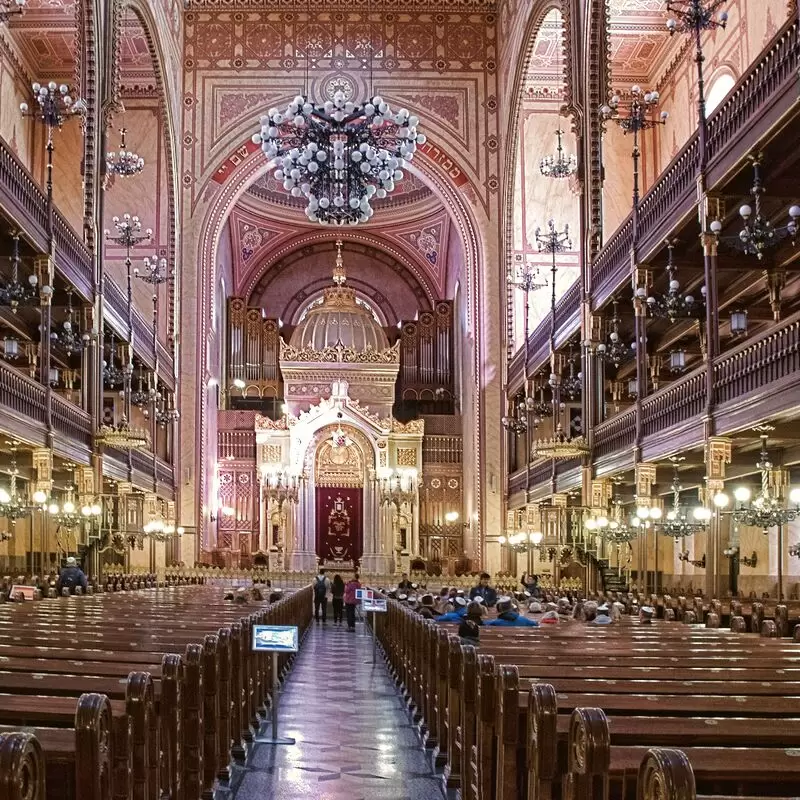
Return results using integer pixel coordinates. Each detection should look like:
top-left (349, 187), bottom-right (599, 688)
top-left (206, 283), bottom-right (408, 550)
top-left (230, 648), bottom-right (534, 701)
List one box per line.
top-left (290, 242), bottom-right (389, 353)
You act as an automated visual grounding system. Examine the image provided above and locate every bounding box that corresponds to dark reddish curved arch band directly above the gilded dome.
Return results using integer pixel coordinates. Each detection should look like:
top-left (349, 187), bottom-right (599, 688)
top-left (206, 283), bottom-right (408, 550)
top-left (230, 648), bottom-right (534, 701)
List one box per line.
top-left (244, 230), bottom-right (436, 320)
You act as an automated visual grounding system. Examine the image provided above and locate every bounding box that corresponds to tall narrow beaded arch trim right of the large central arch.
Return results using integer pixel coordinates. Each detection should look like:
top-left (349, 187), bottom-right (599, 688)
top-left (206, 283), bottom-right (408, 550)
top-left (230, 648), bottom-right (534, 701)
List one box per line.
top-left (501, 0), bottom-right (582, 360)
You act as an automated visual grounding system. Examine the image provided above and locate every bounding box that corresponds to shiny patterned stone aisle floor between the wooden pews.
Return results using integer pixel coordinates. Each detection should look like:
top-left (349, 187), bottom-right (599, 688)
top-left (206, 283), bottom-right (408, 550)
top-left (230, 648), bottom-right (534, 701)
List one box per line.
top-left (234, 622), bottom-right (443, 800)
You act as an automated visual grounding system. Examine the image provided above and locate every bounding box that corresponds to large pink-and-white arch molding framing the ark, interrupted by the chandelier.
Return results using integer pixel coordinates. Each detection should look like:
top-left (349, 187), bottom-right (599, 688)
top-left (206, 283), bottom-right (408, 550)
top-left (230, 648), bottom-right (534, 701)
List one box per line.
top-left (195, 139), bottom-right (482, 561)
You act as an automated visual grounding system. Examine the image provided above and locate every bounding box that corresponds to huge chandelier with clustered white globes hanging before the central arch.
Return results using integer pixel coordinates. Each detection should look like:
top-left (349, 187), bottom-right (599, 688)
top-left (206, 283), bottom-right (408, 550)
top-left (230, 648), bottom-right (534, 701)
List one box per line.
top-left (253, 92), bottom-right (425, 225)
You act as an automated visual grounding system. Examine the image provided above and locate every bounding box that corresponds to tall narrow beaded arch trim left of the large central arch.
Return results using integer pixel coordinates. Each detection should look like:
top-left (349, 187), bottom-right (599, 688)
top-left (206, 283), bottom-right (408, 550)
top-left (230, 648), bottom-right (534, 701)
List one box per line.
top-left (107, 0), bottom-right (180, 340)
